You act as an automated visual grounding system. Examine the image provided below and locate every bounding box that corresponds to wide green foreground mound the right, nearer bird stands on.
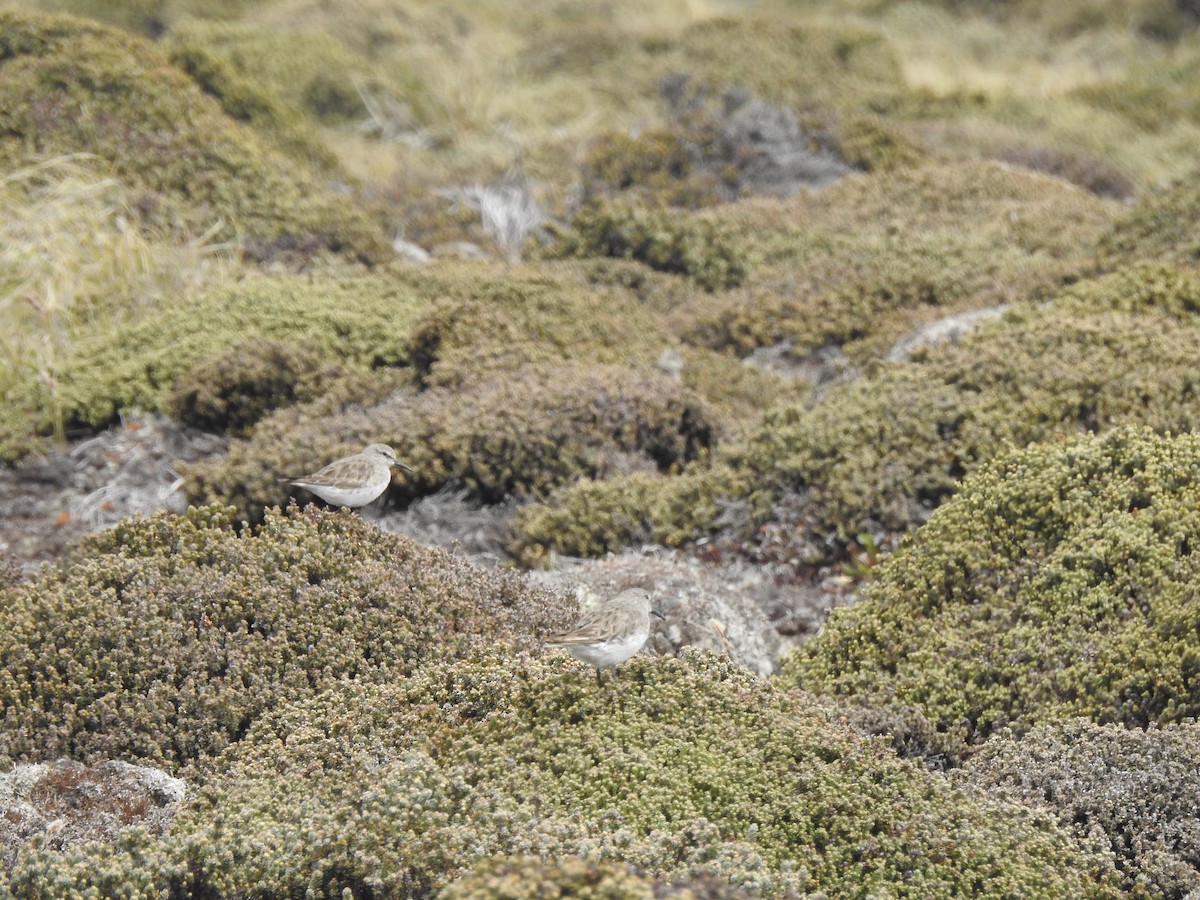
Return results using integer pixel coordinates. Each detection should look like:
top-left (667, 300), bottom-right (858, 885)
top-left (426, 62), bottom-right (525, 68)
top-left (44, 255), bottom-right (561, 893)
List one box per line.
top-left (0, 653), bottom-right (1117, 898)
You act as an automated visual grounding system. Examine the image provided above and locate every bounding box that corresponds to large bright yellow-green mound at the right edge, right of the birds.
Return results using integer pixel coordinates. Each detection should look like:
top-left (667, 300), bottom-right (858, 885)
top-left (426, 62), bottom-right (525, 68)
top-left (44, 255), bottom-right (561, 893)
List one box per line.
top-left (780, 428), bottom-right (1200, 742)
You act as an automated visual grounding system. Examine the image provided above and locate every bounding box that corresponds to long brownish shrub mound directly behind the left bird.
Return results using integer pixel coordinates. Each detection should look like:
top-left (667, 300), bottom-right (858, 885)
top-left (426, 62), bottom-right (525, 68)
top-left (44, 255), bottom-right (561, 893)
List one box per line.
top-left (185, 365), bottom-right (716, 521)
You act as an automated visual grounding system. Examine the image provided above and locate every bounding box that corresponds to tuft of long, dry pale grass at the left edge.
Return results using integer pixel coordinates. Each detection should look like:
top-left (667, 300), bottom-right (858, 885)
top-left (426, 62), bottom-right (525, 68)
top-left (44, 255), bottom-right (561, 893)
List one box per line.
top-left (0, 155), bottom-right (234, 448)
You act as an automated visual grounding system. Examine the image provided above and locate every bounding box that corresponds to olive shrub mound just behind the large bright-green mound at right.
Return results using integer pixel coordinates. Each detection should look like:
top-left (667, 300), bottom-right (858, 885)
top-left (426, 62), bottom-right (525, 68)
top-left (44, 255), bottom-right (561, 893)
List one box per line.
top-left (743, 307), bottom-right (1200, 539)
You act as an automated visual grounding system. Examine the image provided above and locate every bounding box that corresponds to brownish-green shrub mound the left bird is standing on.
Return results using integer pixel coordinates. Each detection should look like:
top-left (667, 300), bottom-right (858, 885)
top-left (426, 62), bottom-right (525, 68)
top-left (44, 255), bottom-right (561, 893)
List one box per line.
top-left (0, 506), bottom-right (553, 764)
